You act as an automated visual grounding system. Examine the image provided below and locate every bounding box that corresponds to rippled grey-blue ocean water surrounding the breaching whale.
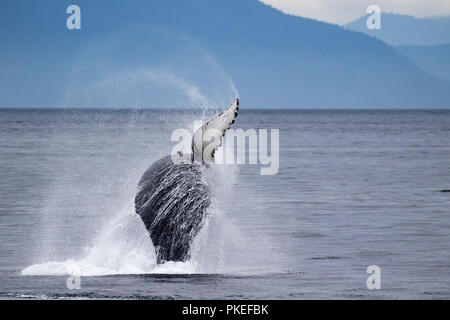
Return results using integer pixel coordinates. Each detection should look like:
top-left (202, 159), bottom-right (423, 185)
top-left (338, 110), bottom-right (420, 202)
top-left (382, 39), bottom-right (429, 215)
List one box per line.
top-left (0, 107), bottom-right (450, 299)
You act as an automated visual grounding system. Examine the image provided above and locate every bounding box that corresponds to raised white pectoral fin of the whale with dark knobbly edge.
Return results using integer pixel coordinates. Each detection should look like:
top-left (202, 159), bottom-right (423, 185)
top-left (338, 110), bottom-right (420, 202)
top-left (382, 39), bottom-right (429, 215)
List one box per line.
top-left (192, 98), bottom-right (239, 163)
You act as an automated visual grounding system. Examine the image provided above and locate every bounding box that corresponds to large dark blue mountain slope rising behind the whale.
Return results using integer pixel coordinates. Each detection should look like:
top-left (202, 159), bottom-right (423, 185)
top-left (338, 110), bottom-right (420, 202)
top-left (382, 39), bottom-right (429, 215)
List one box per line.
top-left (0, 0), bottom-right (450, 108)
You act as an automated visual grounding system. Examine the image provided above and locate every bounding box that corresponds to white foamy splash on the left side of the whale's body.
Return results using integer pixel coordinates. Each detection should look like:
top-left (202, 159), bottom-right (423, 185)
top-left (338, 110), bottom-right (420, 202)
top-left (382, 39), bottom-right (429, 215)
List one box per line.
top-left (22, 201), bottom-right (199, 276)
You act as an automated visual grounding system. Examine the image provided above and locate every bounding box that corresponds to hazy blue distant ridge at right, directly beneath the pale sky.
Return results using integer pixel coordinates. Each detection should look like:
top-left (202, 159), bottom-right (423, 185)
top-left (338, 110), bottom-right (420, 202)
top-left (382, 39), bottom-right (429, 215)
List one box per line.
top-left (345, 13), bottom-right (450, 46)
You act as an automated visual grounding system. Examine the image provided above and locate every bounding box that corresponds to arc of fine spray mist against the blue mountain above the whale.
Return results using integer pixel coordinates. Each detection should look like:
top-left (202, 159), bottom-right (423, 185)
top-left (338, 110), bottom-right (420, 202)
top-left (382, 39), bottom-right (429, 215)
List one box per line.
top-left (61, 26), bottom-right (238, 109)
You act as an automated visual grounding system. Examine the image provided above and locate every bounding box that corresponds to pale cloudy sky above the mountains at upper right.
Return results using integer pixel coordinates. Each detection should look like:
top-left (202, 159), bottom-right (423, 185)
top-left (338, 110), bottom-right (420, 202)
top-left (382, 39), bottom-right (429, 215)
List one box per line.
top-left (261, 0), bottom-right (450, 24)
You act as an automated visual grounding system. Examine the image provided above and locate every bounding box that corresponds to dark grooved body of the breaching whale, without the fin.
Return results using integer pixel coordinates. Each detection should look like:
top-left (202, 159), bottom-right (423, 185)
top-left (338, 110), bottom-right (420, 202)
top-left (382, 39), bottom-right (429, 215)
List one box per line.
top-left (135, 156), bottom-right (211, 263)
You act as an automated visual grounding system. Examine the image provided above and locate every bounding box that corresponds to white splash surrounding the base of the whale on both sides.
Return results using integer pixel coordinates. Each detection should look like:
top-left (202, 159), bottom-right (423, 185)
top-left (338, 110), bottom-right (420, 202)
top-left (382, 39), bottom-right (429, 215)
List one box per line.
top-left (22, 151), bottom-right (282, 276)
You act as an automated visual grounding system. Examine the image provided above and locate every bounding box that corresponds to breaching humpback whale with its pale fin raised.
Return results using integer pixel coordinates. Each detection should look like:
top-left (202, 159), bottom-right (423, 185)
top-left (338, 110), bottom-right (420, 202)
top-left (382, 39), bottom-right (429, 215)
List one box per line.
top-left (135, 98), bottom-right (239, 264)
